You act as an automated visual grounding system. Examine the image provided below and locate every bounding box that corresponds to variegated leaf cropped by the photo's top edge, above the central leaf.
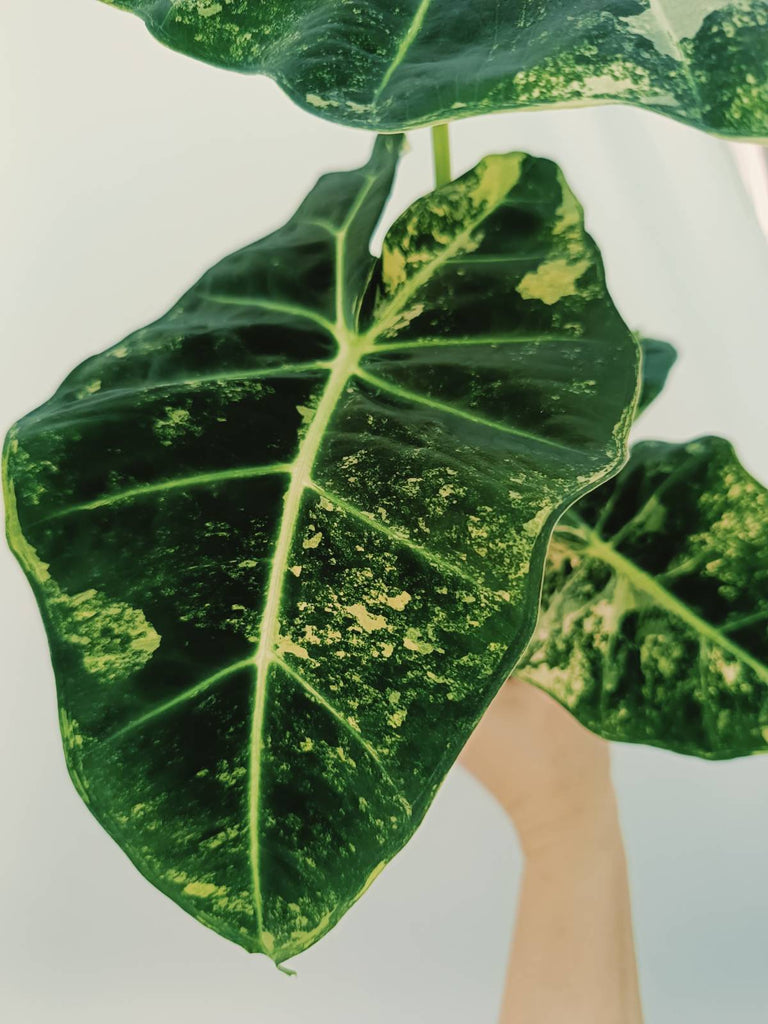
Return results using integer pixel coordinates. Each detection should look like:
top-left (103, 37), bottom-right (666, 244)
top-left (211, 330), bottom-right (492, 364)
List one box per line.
top-left (99, 0), bottom-right (768, 138)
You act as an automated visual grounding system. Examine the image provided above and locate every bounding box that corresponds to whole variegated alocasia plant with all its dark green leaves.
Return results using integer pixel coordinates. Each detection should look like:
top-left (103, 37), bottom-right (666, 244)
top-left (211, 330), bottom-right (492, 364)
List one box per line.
top-left (4, 0), bottom-right (768, 978)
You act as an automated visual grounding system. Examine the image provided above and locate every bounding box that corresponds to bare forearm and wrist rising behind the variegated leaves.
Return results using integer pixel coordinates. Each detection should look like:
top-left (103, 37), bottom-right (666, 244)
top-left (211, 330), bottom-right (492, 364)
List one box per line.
top-left (461, 678), bottom-right (642, 1024)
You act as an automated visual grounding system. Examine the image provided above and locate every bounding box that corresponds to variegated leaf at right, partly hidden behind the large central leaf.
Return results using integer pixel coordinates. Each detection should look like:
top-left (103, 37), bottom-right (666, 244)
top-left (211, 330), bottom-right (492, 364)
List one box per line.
top-left (517, 437), bottom-right (768, 758)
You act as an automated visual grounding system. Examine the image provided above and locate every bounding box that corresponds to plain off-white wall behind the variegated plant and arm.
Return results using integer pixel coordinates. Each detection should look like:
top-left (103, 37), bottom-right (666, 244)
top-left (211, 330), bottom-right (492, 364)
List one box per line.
top-left (0, 0), bottom-right (768, 1024)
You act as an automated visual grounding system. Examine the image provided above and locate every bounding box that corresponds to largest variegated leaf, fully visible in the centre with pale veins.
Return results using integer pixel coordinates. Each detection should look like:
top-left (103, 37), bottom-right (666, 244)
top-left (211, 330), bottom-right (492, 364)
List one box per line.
top-left (6, 136), bottom-right (637, 962)
